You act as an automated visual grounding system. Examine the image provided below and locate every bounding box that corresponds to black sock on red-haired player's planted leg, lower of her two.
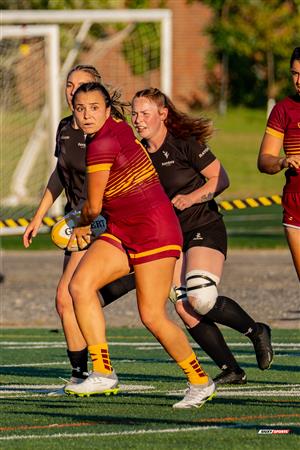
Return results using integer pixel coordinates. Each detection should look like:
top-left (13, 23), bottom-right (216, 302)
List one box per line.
top-left (187, 317), bottom-right (241, 371)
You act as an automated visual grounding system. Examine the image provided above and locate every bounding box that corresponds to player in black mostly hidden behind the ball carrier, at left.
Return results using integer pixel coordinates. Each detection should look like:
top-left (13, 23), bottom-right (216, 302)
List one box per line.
top-left (23, 65), bottom-right (135, 395)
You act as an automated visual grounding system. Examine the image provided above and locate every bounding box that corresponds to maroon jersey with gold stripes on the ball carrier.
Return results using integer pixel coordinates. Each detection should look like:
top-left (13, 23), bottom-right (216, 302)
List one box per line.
top-left (86, 117), bottom-right (166, 217)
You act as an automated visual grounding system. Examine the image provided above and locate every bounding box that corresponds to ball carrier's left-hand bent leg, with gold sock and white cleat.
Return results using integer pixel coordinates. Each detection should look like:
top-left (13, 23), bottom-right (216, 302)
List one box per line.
top-left (66, 240), bottom-right (129, 396)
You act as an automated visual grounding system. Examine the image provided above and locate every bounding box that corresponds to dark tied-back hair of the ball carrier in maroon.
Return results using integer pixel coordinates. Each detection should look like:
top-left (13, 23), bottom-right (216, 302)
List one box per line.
top-left (72, 82), bottom-right (129, 121)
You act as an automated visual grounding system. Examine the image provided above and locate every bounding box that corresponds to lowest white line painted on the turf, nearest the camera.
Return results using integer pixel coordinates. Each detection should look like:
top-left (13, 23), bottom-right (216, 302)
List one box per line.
top-left (0, 425), bottom-right (224, 441)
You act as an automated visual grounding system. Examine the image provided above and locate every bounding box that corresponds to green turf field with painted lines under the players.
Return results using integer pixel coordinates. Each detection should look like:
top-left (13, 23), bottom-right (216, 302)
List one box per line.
top-left (0, 328), bottom-right (300, 450)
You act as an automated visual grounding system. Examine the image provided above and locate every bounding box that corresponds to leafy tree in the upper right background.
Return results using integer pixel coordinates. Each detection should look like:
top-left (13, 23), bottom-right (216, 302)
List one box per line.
top-left (192, 0), bottom-right (300, 112)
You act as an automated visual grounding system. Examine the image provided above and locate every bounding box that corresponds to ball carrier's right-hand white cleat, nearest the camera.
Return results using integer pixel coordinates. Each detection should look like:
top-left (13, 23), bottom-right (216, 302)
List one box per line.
top-left (173, 380), bottom-right (216, 409)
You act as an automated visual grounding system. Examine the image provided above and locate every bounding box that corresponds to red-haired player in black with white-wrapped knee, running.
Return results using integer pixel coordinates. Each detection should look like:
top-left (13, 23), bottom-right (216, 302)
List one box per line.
top-left (132, 88), bottom-right (273, 384)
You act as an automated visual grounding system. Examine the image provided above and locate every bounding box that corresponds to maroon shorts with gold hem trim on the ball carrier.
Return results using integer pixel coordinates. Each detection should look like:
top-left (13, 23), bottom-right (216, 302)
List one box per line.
top-left (98, 202), bottom-right (182, 265)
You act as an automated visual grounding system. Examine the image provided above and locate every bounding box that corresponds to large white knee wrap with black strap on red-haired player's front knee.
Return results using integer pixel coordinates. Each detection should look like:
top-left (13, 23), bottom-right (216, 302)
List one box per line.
top-left (186, 270), bottom-right (220, 316)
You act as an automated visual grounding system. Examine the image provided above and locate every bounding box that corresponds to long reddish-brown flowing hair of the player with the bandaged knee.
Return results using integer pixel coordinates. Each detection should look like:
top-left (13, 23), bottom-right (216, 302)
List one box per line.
top-left (132, 88), bottom-right (213, 143)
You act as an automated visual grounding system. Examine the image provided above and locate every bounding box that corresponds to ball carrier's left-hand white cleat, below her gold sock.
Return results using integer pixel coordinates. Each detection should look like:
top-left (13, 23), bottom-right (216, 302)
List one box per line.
top-left (65, 371), bottom-right (119, 397)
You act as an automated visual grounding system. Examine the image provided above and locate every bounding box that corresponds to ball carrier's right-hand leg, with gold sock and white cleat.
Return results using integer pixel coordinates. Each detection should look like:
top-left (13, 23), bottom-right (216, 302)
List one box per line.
top-left (134, 257), bottom-right (215, 408)
